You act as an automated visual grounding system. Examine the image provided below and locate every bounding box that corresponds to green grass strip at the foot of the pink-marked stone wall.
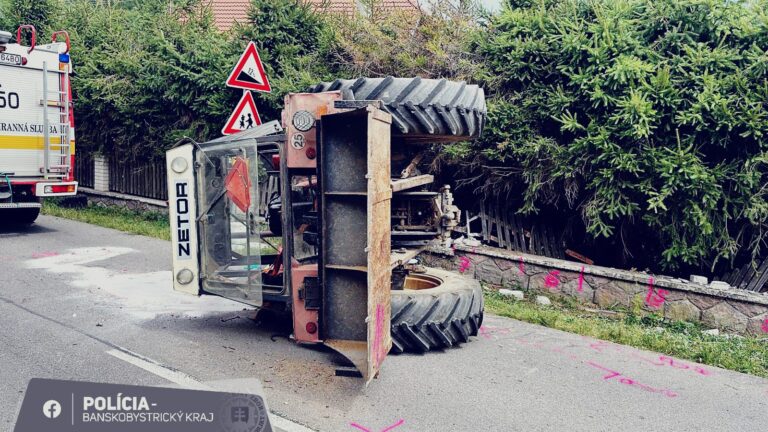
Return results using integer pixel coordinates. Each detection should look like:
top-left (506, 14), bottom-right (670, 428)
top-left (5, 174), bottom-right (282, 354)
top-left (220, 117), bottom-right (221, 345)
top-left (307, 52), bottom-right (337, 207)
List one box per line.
top-left (485, 291), bottom-right (768, 378)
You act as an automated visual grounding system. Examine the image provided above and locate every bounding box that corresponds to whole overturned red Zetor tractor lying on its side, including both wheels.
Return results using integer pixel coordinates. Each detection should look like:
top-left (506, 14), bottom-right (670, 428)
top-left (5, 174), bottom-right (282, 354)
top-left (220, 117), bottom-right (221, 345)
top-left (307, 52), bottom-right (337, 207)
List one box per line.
top-left (167, 77), bottom-right (486, 382)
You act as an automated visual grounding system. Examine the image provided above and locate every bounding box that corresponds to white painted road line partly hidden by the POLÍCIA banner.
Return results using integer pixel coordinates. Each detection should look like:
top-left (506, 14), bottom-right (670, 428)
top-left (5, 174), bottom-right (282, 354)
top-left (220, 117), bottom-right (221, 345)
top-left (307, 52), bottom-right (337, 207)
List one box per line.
top-left (107, 348), bottom-right (315, 432)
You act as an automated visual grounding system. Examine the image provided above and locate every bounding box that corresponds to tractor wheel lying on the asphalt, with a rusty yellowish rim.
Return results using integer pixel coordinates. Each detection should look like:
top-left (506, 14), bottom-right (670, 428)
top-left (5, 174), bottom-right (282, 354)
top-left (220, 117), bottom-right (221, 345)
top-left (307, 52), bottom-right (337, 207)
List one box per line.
top-left (391, 268), bottom-right (484, 353)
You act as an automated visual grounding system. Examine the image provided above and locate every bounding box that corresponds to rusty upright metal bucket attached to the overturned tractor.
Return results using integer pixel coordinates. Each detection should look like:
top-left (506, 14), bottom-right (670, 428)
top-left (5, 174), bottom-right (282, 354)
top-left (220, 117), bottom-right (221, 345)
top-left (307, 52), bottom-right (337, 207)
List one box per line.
top-left (318, 105), bottom-right (392, 385)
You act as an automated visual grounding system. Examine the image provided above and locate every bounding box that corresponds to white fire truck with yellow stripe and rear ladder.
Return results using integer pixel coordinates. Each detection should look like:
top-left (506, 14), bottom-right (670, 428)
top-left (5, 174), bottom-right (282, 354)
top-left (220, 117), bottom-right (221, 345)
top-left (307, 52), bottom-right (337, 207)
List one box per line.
top-left (0, 25), bottom-right (77, 224)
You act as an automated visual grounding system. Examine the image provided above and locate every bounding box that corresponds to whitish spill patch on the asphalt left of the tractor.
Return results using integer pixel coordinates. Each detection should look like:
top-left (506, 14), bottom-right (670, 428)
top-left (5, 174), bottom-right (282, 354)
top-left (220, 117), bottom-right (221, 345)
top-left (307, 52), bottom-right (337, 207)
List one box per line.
top-left (25, 247), bottom-right (243, 319)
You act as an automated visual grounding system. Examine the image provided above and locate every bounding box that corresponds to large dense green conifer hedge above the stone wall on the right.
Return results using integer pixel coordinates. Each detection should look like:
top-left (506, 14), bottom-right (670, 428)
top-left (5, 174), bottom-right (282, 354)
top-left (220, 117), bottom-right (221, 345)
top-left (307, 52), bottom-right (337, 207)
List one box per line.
top-left (460, 0), bottom-right (768, 269)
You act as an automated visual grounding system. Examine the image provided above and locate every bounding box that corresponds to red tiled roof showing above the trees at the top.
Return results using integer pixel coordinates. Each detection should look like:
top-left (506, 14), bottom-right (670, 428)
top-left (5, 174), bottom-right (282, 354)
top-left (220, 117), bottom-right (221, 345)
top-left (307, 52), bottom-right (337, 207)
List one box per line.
top-left (208, 0), bottom-right (419, 30)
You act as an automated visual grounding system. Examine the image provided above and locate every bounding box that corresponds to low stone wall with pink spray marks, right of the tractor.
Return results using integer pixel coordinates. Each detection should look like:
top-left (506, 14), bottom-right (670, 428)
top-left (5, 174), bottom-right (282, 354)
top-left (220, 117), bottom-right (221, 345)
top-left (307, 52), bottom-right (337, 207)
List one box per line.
top-left (421, 245), bottom-right (768, 335)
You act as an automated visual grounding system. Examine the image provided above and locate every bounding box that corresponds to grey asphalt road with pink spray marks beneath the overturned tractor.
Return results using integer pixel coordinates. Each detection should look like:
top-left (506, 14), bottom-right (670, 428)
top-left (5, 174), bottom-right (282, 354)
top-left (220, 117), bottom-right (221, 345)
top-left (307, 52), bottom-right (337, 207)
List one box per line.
top-left (0, 217), bottom-right (768, 432)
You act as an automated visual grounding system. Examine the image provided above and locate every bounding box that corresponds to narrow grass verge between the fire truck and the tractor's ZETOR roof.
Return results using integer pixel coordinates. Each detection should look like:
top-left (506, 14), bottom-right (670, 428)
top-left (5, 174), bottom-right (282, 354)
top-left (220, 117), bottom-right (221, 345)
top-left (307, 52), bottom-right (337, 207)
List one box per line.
top-left (43, 200), bottom-right (171, 240)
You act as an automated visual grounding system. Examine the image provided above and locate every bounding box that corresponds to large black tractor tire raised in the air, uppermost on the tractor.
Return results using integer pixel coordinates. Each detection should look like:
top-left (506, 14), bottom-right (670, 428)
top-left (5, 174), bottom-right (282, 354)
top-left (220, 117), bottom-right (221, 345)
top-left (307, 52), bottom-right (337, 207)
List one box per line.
top-left (309, 77), bottom-right (487, 141)
